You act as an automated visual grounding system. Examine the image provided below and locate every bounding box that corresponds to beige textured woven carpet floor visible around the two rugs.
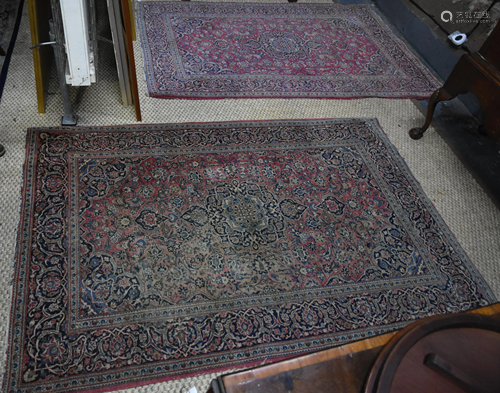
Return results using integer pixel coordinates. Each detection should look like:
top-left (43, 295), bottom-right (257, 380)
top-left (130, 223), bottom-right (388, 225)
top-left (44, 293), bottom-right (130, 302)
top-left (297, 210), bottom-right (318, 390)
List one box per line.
top-left (0, 1), bottom-right (500, 392)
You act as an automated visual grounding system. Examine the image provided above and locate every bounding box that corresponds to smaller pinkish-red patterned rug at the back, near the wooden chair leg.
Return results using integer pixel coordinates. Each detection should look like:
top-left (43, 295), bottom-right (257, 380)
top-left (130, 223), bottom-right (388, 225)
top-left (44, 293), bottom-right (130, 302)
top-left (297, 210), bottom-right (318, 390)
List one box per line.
top-left (137, 1), bottom-right (439, 99)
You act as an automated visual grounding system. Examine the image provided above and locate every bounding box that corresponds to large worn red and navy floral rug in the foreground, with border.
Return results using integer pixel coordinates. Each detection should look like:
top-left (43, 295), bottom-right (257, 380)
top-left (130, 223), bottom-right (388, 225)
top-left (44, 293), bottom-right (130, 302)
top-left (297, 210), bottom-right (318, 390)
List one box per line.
top-left (4, 119), bottom-right (494, 392)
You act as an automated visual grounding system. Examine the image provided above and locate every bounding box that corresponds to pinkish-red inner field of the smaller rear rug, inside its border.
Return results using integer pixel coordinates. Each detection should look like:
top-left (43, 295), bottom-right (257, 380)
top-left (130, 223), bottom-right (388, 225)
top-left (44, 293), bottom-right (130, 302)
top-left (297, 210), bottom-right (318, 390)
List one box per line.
top-left (173, 16), bottom-right (382, 78)
